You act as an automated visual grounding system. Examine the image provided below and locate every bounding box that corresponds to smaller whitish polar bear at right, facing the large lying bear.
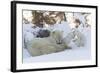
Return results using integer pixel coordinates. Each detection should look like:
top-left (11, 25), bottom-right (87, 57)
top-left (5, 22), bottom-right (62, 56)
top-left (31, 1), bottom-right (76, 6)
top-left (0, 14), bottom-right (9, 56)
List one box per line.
top-left (63, 29), bottom-right (86, 47)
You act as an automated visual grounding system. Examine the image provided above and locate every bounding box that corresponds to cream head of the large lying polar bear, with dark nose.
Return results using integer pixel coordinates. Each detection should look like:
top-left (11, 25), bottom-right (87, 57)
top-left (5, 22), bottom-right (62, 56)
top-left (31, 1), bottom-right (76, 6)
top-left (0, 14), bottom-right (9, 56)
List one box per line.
top-left (50, 30), bottom-right (63, 44)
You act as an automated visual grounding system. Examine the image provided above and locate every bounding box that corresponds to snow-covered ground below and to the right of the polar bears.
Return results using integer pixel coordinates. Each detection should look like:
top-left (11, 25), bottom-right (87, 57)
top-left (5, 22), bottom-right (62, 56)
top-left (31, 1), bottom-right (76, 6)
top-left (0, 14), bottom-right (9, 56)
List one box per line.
top-left (23, 21), bottom-right (91, 63)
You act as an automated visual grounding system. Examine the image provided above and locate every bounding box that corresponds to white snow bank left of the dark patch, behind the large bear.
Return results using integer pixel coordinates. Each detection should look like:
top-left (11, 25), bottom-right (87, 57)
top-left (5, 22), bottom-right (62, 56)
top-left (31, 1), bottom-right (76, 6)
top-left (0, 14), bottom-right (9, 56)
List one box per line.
top-left (23, 23), bottom-right (40, 47)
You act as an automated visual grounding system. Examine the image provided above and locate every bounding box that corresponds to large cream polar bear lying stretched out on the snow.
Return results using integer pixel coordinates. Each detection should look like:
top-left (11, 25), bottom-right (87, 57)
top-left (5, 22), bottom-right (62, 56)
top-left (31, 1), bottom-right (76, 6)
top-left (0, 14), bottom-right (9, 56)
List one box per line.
top-left (27, 30), bottom-right (68, 56)
